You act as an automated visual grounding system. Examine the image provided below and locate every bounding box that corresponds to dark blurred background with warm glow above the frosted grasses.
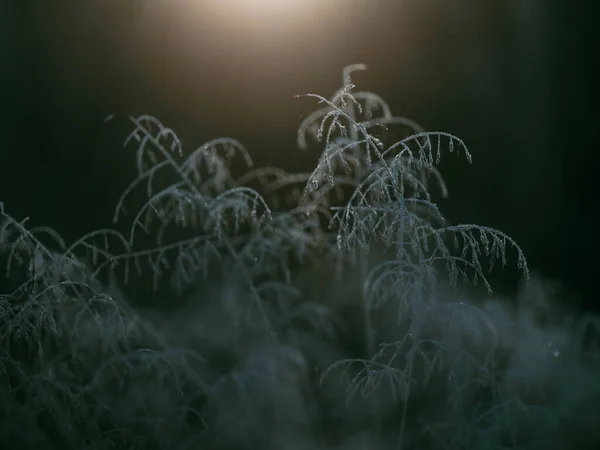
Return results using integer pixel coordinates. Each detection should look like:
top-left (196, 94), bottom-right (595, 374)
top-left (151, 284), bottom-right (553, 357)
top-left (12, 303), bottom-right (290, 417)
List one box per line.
top-left (0, 0), bottom-right (600, 305)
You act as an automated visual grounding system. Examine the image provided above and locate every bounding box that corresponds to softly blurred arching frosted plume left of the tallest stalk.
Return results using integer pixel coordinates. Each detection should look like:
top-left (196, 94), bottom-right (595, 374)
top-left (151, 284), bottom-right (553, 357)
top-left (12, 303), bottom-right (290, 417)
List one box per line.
top-left (109, 116), bottom-right (271, 302)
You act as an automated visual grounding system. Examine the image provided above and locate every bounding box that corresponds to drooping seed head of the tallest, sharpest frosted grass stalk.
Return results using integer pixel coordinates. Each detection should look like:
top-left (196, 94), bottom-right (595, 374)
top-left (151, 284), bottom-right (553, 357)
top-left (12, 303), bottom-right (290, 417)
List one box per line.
top-left (299, 65), bottom-right (527, 288)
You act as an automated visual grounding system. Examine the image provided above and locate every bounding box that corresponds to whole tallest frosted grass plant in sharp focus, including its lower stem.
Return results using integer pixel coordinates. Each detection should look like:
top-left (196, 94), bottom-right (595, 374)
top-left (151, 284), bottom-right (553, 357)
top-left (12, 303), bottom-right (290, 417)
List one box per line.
top-left (298, 65), bottom-right (528, 446)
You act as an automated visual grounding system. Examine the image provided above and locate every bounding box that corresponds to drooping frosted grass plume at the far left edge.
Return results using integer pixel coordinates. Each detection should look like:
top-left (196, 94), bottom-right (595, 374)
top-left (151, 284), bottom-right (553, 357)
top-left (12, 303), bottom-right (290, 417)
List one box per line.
top-left (0, 205), bottom-right (137, 370)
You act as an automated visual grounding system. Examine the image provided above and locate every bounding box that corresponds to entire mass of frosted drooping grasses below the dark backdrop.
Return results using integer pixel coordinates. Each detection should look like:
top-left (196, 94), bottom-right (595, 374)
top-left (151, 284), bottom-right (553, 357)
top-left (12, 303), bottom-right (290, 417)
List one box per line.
top-left (0, 65), bottom-right (596, 450)
